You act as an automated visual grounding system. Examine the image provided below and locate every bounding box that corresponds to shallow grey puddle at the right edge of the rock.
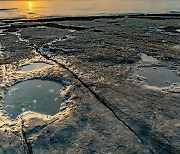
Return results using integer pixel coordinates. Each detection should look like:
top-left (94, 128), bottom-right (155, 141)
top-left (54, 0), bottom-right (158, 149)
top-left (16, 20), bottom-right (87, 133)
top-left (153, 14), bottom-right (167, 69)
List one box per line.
top-left (138, 67), bottom-right (180, 87)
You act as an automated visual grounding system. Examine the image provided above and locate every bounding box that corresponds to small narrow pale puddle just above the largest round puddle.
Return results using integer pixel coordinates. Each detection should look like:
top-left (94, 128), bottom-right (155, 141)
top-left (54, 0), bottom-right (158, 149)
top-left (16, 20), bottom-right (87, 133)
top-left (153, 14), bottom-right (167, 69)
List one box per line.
top-left (19, 62), bottom-right (49, 71)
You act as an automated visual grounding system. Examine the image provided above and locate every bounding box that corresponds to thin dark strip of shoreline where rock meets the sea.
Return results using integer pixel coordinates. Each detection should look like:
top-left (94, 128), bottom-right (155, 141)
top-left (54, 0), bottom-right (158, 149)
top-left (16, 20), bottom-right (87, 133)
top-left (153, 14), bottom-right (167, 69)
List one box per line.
top-left (0, 11), bottom-right (180, 23)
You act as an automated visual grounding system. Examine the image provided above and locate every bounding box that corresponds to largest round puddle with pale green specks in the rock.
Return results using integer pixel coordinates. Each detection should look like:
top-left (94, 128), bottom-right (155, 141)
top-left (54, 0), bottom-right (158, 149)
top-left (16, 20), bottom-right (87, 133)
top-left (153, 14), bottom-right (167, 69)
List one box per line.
top-left (3, 79), bottom-right (63, 119)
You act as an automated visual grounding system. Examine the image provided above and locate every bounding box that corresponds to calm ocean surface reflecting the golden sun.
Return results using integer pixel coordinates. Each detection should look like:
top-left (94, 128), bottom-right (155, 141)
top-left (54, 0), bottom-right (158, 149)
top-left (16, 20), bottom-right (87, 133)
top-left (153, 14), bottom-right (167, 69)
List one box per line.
top-left (0, 0), bottom-right (180, 19)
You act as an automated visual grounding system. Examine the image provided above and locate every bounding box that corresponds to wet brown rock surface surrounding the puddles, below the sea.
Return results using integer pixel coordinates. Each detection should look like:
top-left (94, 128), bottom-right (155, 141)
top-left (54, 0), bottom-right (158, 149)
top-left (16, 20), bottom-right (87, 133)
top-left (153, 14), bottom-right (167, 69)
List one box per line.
top-left (0, 15), bottom-right (180, 154)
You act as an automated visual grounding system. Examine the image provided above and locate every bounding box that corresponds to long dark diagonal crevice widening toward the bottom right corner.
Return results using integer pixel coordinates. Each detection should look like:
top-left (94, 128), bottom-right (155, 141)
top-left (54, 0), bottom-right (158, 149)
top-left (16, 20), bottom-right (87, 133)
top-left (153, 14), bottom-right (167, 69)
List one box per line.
top-left (35, 38), bottom-right (178, 154)
